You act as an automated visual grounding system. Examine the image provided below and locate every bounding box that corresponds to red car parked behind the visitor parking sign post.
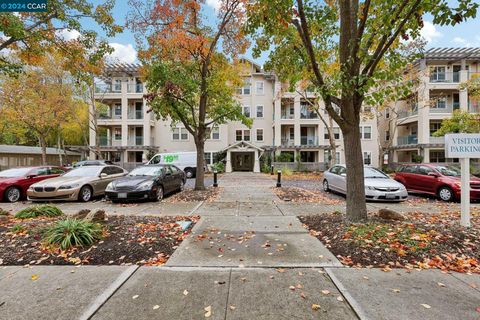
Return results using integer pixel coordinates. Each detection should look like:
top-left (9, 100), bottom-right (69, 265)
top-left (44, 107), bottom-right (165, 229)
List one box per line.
top-left (394, 164), bottom-right (480, 201)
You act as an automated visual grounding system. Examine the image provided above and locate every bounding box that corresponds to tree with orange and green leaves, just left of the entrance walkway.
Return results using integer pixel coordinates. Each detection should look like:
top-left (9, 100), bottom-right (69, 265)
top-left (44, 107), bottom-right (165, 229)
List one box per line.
top-left (128, 0), bottom-right (251, 190)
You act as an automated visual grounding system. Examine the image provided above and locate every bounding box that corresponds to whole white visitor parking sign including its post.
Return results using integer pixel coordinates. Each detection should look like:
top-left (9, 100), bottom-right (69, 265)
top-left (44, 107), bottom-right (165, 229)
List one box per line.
top-left (445, 133), bottom-right (480, 227)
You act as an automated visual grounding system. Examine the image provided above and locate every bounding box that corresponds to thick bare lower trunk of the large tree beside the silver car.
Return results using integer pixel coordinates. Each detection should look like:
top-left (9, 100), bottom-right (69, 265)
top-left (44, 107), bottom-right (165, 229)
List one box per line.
top-left (343, 121), bottom-right (367, 222)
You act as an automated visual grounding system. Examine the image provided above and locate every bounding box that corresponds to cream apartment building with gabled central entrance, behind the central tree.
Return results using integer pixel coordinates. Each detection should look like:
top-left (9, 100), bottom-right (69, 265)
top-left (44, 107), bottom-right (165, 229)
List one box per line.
top-left (90, 60), bottom-right (378, 172)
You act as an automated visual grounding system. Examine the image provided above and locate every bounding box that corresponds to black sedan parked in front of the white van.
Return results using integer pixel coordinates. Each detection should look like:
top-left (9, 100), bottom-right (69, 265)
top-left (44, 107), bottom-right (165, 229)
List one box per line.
top-left (105, 165), bottom-right (186, 202)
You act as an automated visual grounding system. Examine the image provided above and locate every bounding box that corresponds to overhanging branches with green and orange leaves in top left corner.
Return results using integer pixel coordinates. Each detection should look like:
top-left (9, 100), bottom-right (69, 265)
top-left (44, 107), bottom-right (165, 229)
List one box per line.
top-left (0, 0), bottom-right (122, 74)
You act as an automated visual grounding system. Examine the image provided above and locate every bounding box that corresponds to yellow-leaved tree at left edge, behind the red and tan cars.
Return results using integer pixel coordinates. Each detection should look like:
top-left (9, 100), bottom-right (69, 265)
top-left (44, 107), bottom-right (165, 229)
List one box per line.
top-left (0, 56), bottom-right (81, 165)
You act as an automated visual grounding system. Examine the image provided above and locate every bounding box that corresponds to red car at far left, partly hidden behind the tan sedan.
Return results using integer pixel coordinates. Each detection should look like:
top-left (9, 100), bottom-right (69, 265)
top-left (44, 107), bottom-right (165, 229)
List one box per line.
top-left (0, 166), bottom-right (67, 202)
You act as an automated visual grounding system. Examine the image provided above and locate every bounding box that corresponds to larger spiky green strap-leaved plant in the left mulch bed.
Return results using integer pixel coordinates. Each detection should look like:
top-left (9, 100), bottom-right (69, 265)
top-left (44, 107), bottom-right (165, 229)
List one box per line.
top-left (43, 218), bottom-right (102, 250)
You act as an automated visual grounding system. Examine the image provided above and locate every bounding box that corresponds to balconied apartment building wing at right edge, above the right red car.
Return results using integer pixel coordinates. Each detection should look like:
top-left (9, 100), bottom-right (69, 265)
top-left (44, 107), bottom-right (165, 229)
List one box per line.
top-left (386, 48), bottom-right (480, 163)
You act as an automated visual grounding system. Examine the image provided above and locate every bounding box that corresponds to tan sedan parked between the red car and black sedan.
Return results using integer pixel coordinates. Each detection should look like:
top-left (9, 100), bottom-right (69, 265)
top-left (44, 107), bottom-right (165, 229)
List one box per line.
top-left (27, 165), bottom-right (128, 202)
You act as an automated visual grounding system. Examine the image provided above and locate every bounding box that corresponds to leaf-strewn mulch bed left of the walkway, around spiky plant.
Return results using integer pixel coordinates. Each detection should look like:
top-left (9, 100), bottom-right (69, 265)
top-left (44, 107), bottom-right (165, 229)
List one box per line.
top-left (0, 216), bottom-right (199, 265)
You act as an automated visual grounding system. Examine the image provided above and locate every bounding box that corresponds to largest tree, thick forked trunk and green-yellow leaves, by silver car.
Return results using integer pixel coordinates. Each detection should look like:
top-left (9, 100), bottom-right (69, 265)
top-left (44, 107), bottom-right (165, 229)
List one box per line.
top-left (246, 0), bottom-right (478, 221)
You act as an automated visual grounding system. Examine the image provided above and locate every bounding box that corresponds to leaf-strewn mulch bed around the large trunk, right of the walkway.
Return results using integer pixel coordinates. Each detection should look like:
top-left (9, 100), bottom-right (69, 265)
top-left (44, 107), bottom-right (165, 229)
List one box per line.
top-left (300, 208), bottom-right (480, 273)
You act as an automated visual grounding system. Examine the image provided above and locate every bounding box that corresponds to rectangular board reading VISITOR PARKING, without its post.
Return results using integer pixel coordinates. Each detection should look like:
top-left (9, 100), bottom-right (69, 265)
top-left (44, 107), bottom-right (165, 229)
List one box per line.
top-left (445, 133), bottom-right (480, 158)
